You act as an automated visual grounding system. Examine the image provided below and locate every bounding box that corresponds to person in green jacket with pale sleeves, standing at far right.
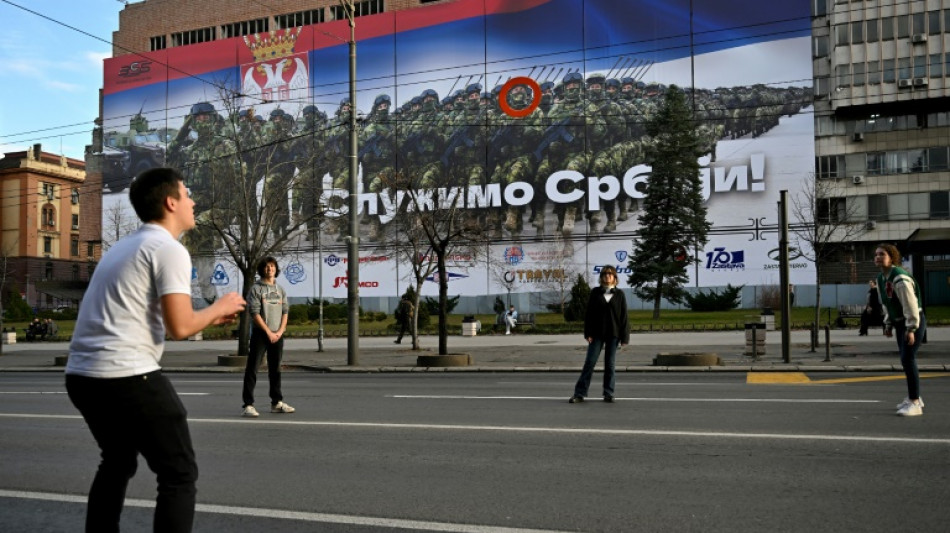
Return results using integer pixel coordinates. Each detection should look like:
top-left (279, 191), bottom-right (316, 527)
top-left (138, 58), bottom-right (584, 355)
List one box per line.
top-left (874, 244), bottom-right (927, 416)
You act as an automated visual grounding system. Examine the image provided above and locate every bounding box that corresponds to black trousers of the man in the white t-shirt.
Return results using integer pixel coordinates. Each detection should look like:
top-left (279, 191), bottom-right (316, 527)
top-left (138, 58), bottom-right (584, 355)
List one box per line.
top-left (66, 370), bottom-right (198, 533)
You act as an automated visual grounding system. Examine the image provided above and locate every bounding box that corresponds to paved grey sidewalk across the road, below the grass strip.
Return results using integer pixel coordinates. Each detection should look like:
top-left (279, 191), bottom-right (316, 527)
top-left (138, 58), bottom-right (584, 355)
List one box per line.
top-left (0, 328), bottom-right (950, 373)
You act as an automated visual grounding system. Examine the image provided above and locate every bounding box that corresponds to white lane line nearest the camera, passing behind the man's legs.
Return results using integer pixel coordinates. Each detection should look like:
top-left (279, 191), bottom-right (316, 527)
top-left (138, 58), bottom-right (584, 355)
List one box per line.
top-left (0, 489), bottom-right (560, 533)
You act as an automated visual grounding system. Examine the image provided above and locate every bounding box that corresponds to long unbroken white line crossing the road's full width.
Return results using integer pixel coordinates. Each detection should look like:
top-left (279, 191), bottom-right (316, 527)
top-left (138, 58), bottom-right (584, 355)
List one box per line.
top-left (0, 413), bottom-right (950, 445)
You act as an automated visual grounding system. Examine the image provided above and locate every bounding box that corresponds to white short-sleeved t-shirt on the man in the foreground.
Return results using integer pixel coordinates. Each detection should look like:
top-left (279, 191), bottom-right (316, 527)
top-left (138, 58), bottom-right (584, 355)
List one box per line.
top-left (66, 224), bottom-right (191, 378)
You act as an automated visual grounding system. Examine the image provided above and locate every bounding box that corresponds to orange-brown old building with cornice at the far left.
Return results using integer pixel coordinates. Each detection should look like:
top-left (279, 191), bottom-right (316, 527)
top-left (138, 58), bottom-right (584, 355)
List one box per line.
top-left (0, 144), bottom-right (100, 309)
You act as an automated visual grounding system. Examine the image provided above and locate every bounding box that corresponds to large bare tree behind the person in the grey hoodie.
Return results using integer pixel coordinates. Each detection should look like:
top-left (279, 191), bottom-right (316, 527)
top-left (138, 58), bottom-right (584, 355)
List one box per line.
top-left (169, 92), bottom-right (324, 355)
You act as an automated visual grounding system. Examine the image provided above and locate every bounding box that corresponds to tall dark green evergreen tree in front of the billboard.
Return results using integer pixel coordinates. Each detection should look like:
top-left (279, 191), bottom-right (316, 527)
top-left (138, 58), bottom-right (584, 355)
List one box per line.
top-left (627, 85), bottom-right (710, 320)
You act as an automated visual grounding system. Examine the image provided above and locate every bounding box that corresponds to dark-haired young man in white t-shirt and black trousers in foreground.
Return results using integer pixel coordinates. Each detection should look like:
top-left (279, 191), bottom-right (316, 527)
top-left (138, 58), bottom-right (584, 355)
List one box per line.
top-left (66, 168), bottom-right (245, 532)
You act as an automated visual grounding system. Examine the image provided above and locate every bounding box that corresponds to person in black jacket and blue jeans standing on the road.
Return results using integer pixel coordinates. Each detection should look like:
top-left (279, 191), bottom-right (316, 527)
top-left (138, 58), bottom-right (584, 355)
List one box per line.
top-left (568, 265), bottom-right (630, 403)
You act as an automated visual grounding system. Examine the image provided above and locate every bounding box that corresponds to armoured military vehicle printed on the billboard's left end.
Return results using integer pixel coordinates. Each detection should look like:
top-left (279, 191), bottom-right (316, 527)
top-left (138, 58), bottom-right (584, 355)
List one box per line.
top-left (102, 111), bottom-right (177, 192)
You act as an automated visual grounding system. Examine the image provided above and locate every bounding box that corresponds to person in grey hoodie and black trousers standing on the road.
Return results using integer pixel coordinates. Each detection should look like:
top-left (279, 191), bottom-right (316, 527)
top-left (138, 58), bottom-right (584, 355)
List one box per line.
top-left (242, 257), bottom-right (296, 418)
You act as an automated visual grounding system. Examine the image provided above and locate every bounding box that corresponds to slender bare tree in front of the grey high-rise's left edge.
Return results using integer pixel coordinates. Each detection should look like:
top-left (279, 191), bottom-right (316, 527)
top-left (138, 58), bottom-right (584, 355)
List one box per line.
top-left (783, 175), bottom-right (866, 334)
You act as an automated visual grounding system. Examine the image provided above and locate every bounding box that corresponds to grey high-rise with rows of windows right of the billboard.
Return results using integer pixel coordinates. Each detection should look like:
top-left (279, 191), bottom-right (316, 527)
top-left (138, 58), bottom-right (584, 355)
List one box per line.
top-left (812, 0), bottom-right (950, 305)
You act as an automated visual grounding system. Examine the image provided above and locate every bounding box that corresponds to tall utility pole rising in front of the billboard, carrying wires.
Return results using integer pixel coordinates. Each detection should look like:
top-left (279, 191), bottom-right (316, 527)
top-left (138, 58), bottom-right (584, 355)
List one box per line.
top-left (340, 0), bottom-right (360, 366)
